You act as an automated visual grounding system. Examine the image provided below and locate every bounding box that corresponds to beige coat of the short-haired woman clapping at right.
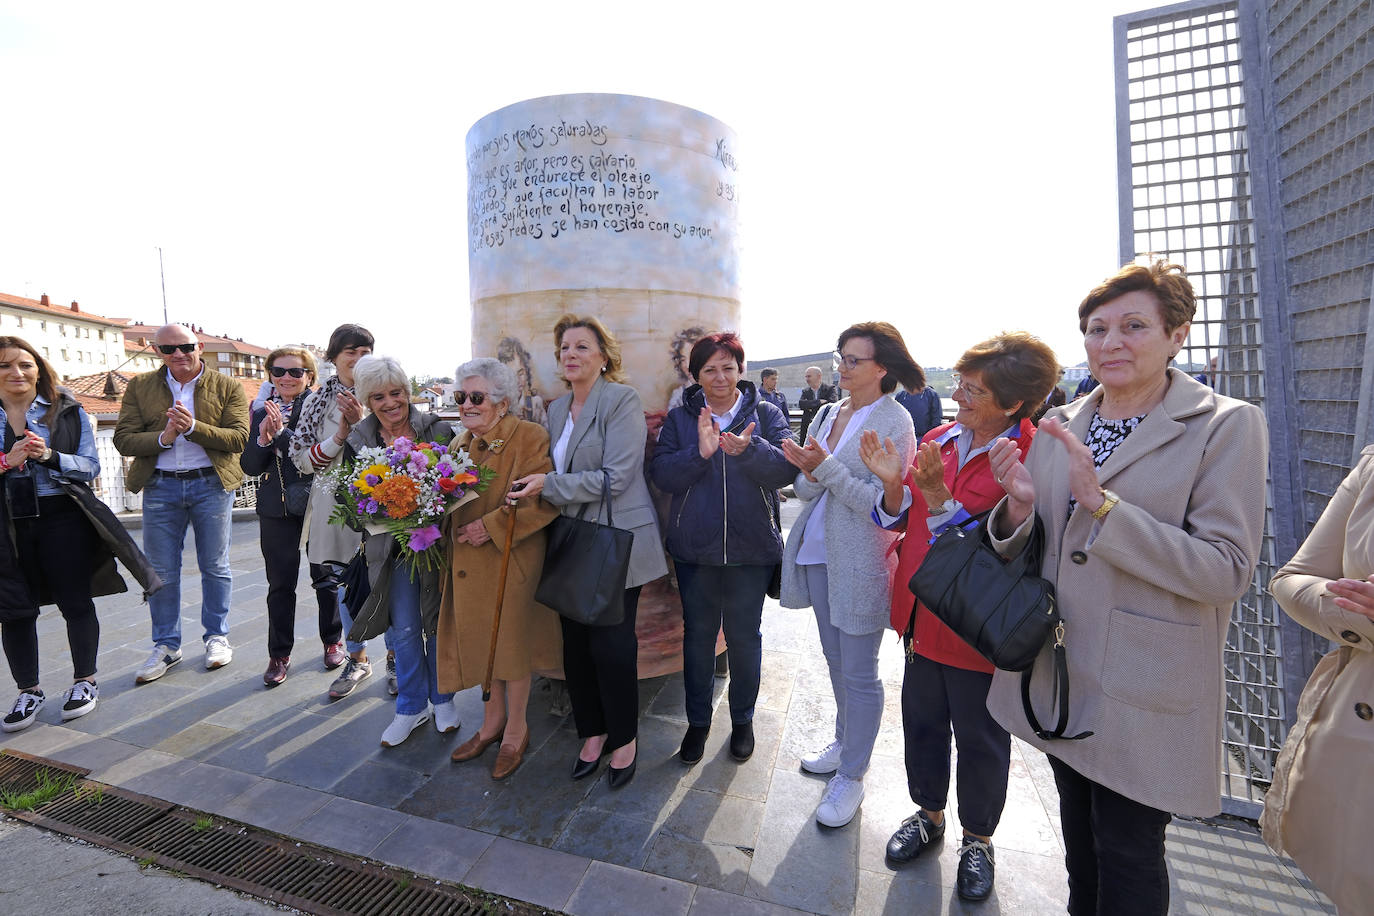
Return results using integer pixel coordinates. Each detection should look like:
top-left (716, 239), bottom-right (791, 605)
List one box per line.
top-left (988, 369), bottom-right (1268, 816)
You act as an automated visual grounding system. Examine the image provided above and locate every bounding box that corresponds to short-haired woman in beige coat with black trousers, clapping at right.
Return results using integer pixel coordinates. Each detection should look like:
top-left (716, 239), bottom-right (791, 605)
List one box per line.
top-left (988, 262), bottom-right (1268, 916)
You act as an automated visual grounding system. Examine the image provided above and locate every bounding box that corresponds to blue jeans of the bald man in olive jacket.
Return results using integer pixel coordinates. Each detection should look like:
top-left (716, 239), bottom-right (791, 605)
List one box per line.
top-left (143, 471), bottom-right (234, 648)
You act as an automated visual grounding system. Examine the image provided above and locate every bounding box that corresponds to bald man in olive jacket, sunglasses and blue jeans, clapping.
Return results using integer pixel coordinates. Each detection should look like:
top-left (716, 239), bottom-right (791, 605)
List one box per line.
top-left (114, 324), bottom-right (249, 684)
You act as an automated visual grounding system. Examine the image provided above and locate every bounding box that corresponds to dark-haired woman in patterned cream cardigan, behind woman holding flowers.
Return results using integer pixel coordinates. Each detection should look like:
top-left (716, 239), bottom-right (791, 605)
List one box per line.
top-left (290, 324), bottom-right (381, 700)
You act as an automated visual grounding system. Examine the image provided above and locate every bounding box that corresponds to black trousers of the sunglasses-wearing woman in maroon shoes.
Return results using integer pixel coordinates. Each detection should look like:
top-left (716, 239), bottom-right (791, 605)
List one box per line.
top-left (258, 515), bottom-right (344, 658)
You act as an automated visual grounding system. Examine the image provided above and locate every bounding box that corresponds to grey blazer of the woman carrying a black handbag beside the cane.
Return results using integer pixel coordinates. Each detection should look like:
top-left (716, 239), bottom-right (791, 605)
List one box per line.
top-left (543, 379), bottom-right (668, 588)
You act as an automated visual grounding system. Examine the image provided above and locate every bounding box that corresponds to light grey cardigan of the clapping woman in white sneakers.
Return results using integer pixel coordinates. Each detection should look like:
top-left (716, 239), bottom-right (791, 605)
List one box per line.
top-left (782, 396), bottom-right (916, 636)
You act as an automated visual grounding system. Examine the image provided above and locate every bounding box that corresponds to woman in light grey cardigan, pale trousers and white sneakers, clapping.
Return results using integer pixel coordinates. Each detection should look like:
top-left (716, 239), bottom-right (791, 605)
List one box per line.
top-left (782, 321), bottom-right (926, 827)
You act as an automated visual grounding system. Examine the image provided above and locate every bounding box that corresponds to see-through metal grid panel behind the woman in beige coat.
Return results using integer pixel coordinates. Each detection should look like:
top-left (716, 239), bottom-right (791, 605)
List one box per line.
top-left (1117, 3), bottom-right (1286, 816)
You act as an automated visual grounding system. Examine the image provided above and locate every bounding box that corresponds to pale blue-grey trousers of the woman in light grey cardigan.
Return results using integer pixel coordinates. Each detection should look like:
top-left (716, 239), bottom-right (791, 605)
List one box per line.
top-left (802, 563), bottom-right (885, 780)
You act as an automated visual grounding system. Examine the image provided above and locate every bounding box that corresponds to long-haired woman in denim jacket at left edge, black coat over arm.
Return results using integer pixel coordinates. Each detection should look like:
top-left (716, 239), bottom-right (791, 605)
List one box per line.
top-left (0, 336), bottom-right (157, 732)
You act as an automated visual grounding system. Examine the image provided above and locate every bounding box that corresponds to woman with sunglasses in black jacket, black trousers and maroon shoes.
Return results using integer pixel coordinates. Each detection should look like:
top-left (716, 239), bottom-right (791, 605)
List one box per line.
top-left (239, 346), bottom-right (344, 687)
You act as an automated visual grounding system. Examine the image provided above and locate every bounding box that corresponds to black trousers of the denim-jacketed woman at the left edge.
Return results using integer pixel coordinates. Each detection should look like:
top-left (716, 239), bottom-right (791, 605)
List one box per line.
top-left (0, 496), bottom-right (100, 689)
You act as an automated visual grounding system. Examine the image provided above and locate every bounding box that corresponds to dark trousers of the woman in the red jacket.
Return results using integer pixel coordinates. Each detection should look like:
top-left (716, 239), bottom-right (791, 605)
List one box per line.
top-left (901, 655), bottom-right (1011, 836)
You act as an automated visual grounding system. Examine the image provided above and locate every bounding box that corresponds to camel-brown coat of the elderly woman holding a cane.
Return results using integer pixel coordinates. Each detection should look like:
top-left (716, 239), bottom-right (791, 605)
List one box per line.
top-left (434, 413), bottom-right (563, 694)
